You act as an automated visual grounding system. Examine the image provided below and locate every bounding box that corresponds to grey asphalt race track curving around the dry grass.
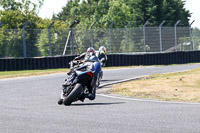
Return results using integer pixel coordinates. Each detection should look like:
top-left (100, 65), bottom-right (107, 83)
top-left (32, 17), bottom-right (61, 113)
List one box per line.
top-left (0, 64), bottom-right (200, 133)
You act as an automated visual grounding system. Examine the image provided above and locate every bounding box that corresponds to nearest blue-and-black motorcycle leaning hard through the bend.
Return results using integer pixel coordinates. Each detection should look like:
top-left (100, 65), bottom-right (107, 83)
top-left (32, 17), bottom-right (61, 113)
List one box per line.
top-left (58, 59), bottom-right (102, 106)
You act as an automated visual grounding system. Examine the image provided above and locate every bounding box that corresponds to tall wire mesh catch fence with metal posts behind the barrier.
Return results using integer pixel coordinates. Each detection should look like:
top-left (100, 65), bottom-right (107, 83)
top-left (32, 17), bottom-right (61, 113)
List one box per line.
top-left (0, 26), bottom-right (194, 58)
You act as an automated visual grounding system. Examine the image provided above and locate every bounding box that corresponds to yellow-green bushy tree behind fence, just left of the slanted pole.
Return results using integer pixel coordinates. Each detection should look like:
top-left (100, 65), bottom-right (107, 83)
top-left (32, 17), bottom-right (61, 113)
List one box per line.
top-left (36, 19), bottom-right (68, 56)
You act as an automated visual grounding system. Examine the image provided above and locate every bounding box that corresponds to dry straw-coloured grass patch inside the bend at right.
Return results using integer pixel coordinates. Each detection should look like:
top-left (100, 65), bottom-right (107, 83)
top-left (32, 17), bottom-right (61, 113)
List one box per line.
top-left (111, 69), bottom-right (200, 102)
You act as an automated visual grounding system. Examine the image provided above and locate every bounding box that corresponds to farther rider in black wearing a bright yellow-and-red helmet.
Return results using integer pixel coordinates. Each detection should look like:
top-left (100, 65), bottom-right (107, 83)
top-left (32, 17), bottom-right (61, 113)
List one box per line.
top-left (96, 46), bottom-right (107, 66)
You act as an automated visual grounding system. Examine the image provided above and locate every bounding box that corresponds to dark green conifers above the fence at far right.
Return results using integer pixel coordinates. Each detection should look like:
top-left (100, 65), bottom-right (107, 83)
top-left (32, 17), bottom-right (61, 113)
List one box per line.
top-left (151, 0), bottom-right (190, 26)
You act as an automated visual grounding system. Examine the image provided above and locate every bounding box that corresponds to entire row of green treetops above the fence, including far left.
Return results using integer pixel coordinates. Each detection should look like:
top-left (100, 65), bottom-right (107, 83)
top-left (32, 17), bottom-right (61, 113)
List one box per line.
top-left (0, 0), bottom-right (190, 29)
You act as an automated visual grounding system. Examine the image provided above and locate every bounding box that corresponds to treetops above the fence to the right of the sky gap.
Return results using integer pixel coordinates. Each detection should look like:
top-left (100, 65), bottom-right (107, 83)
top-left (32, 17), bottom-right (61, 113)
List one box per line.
top-left (53, 0), bottom-right (190, 28)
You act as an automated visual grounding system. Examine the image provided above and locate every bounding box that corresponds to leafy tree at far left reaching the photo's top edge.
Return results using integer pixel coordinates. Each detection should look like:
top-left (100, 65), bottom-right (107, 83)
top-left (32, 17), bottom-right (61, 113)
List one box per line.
top-left (0, 0), bottom-right (43, 57)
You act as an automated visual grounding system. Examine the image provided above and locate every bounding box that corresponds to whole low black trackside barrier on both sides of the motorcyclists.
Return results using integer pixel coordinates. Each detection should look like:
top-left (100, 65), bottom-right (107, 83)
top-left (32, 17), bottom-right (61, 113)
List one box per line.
top-left (0, 51), bottom-right (200, 71)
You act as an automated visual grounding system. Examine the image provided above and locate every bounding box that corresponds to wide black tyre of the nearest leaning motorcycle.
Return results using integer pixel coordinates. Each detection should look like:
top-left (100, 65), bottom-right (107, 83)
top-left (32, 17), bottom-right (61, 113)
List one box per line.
top-left (63, 83), bottom-right (83, 106)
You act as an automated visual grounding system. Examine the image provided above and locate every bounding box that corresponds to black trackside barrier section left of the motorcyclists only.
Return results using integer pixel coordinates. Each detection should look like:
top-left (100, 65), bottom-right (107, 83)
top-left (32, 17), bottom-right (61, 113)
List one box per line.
top-left (0, 56), bottom-right (75, 71)
